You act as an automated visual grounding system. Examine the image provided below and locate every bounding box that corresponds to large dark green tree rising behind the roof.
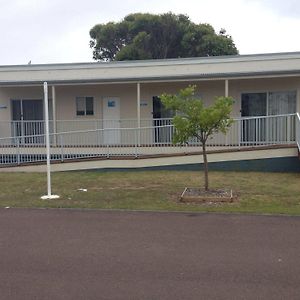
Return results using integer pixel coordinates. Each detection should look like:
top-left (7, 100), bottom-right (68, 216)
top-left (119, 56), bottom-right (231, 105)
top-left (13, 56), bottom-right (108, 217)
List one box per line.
top-left (90, 13), bottom-right (238, 61)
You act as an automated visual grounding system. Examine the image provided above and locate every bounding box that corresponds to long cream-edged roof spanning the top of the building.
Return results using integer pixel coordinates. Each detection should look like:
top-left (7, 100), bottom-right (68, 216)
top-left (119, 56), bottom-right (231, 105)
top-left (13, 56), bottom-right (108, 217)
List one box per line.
top-left (0, 52), bottom-right (300, 86)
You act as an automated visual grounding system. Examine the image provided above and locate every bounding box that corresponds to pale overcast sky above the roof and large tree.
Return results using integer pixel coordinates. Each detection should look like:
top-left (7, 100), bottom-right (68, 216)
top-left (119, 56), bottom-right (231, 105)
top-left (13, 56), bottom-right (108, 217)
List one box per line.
top-left (0, 0), bottom-right (300, 65)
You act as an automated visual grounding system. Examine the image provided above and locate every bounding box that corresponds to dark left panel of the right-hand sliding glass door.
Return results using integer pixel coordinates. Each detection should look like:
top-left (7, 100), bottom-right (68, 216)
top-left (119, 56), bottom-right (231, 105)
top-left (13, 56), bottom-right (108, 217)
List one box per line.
top-left (241, 93), bottom-right (267, 144)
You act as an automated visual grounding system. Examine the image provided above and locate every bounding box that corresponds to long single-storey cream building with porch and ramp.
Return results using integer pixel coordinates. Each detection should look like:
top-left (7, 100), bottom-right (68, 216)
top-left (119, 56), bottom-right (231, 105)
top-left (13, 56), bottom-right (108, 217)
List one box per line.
top-left (0, 52), bottom-right (300, 171)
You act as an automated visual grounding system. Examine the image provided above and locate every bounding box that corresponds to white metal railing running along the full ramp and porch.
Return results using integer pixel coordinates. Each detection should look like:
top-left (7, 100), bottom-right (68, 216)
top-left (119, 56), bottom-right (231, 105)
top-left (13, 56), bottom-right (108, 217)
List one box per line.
top-left (0, 114), bottom-right (300, 165)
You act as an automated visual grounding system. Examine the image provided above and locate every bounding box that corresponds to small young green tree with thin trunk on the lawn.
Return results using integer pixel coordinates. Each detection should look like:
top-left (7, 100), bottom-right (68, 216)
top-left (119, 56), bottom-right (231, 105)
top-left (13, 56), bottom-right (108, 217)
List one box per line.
top-left (161, 85), bottom-right (233, 191)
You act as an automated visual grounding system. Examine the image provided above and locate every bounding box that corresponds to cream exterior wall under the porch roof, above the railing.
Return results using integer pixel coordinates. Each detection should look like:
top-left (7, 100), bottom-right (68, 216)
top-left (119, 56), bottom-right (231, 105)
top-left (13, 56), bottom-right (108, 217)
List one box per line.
top-left (0, 77), bottom-right (300, 126)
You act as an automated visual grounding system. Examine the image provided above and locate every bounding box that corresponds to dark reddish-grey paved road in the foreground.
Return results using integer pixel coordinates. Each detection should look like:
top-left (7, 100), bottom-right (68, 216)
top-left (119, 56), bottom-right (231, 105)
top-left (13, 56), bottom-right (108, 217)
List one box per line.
top-left (0, 209), bottom-right (300, 300)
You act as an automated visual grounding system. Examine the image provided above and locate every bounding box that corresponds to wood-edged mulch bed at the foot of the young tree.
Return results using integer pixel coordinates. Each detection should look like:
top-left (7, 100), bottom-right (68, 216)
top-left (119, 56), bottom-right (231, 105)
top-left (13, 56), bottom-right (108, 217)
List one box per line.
top-left (180, 188), bottom-right (237, 203)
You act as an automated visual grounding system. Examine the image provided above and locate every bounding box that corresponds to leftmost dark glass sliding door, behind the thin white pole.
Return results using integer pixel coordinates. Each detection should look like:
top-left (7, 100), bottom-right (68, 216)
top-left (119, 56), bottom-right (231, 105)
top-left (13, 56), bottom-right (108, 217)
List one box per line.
top-left (11, 100), bottom-right (44, 143)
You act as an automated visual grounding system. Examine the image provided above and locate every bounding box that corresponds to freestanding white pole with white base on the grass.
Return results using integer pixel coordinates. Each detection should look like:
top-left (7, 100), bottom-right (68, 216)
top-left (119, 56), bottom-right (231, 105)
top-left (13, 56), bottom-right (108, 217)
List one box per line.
top-left (41, 82), bottom-right (59, 200)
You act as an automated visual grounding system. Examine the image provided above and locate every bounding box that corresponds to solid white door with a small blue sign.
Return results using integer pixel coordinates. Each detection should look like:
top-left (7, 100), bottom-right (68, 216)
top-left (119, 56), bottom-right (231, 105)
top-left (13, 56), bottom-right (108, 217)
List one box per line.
top-left (103, 97), bottom-right (121, 145)
